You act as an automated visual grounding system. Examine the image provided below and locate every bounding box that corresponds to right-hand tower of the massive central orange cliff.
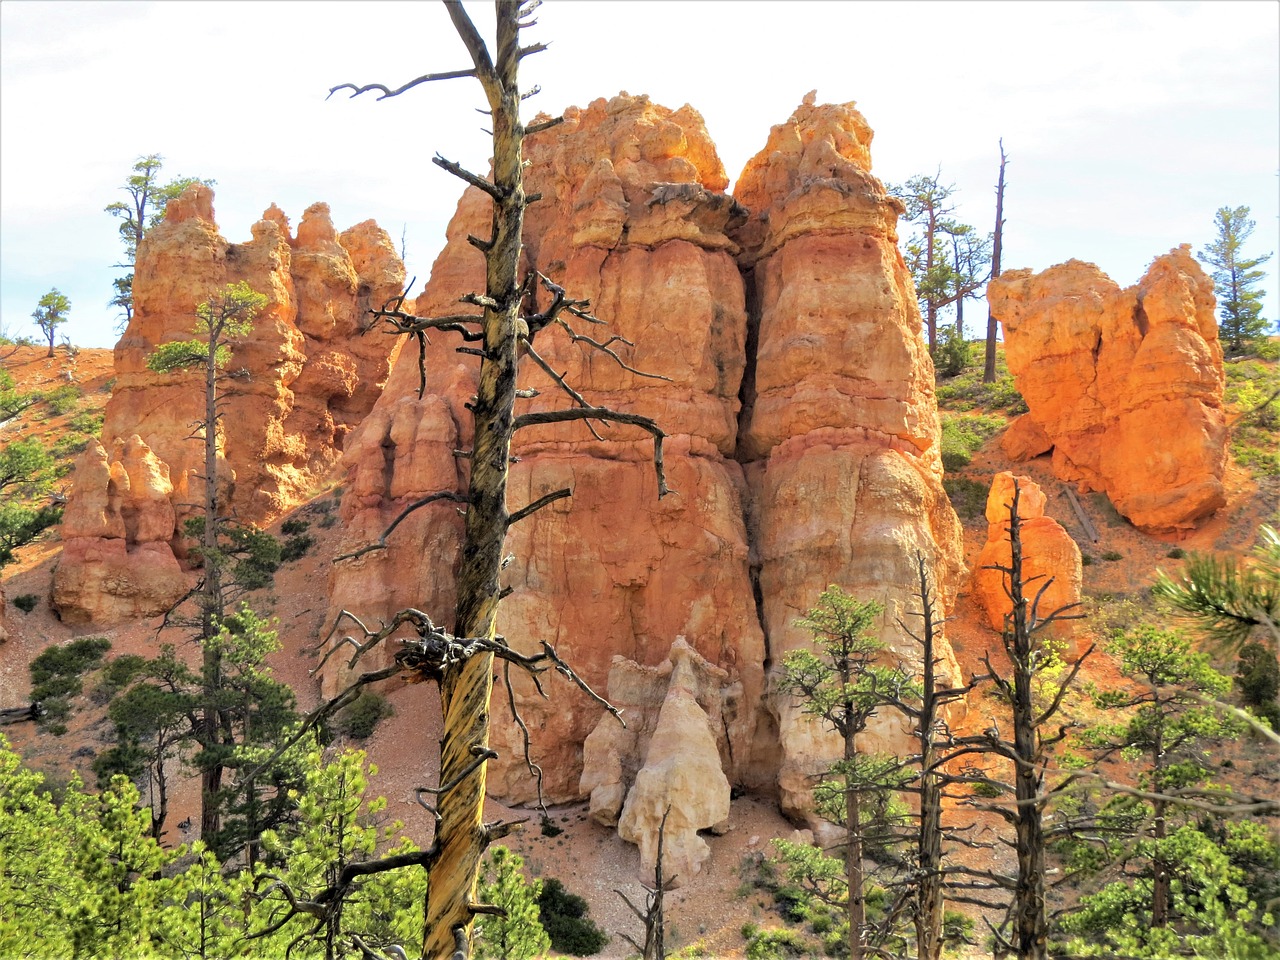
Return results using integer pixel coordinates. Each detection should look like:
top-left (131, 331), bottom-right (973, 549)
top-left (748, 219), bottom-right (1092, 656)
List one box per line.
top-left (735, 93), bottom-right (964, 815)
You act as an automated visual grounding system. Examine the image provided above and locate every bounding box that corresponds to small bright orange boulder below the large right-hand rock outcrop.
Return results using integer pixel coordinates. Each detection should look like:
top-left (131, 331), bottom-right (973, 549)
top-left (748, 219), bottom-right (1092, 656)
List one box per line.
top-left (973, 471), bottom-right (1084, 634)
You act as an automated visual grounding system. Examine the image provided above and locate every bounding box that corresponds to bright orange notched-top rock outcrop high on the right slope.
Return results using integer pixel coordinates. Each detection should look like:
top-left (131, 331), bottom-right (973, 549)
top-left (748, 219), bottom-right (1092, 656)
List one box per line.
top-left (987, 244), bottom-right (1226, 532)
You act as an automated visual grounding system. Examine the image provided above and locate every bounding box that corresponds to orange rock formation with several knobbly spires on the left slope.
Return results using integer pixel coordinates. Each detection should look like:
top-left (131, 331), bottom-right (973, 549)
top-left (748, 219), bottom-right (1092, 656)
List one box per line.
top-left (54, 184), bottom-right (404, 625)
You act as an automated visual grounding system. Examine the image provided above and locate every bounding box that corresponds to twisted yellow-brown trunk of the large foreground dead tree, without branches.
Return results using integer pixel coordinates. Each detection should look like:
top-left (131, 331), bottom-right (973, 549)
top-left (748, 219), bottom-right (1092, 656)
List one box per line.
top-left (422, 3), bottom-right (527, 960)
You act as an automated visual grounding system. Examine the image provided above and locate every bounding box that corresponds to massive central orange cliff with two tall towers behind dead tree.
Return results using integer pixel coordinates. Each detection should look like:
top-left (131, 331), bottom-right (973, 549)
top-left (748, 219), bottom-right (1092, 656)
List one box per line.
top-left (325, 95), bottom-right (963, 855)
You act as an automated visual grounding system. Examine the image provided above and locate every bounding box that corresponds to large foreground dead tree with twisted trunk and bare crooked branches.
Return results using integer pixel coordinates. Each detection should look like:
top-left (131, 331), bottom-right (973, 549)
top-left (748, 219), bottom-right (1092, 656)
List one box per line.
top-left (318, 0), bottom-right (668, 960)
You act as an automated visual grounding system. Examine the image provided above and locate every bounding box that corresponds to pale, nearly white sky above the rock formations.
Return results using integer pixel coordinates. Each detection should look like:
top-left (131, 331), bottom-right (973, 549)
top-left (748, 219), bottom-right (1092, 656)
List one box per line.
top-left (0, 0), bottom-right (1280, 347)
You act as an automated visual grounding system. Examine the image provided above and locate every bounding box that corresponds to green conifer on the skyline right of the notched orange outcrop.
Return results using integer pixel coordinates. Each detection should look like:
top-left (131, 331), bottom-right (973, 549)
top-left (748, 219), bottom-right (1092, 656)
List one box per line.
top-left (1199, 206), bottom-right (1271, 353)
